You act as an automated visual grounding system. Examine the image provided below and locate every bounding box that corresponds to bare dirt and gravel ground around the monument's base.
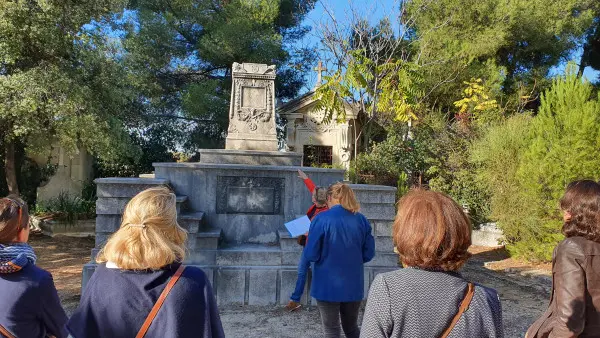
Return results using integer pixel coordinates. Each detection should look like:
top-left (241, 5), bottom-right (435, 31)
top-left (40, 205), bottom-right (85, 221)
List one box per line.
top-left (30, 235), bottom-right (550, 338)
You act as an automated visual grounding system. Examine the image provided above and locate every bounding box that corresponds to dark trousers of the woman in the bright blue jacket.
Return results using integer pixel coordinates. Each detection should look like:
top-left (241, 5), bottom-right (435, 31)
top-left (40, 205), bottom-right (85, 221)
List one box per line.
top-left (317, 300), bottom-right (362, 338)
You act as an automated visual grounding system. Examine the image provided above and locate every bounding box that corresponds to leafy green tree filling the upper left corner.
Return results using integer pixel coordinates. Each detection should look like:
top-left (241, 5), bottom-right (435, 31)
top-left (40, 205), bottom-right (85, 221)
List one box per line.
top-left (0, 0), bottom-right (130, 193)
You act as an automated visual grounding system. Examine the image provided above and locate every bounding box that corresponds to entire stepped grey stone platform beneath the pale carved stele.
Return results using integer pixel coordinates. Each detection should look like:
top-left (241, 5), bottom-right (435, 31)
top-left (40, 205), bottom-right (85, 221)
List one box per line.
top-left (82, 154), bottom-right (398, 305)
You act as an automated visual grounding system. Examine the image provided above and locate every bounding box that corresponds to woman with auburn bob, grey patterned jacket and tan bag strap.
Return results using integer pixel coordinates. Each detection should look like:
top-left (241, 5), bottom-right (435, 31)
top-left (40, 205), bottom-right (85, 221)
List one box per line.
top-left (360, 189), bottom-right (503, 338)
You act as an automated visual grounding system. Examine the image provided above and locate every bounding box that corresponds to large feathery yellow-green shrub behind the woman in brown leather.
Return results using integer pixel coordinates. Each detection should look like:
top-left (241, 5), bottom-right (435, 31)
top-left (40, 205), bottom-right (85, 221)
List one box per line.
top-left (473, 66), bottom-right (600, 261)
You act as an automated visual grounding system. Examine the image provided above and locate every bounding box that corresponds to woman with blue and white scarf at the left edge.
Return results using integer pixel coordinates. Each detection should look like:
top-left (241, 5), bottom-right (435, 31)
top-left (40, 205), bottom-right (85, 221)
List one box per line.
top-left (0, 198), bottom-right (67, 338)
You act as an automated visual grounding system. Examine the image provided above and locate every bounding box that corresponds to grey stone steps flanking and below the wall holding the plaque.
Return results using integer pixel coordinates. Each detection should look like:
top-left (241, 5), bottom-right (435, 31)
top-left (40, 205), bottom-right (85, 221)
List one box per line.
top-left (82, 178), bottom-right (398, 305)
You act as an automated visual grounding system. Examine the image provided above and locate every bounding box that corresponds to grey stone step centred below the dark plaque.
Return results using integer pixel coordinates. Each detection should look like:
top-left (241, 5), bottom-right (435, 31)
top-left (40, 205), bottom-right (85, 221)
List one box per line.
top-left (216, 244), bottom-right (281, 266)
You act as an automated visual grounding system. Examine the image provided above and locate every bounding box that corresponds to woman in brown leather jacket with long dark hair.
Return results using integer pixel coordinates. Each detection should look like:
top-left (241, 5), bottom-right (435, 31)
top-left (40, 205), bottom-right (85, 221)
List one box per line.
top-left (527, 180), bottom-right (600, 338)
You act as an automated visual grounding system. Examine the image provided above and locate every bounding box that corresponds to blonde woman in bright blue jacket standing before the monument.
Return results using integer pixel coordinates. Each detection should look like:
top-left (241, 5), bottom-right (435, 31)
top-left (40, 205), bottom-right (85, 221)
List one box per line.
top-left (304, 183), bottom-right (375, 338)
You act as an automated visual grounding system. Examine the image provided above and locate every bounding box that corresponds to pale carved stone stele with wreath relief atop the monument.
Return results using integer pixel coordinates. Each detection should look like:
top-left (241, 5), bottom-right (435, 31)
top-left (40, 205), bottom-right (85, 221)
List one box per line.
top-left (225, 62), bottom-right (278, 151)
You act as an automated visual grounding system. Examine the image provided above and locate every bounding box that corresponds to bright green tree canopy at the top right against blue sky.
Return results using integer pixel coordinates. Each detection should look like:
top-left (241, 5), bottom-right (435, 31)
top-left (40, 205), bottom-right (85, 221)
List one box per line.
top-left (406, 0), bottom-right (600, 107)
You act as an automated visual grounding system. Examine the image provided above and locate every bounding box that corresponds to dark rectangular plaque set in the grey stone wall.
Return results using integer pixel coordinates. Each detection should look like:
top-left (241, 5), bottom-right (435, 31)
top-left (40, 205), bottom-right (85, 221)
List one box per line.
top-left (217, 176), bottom-right (284, 215)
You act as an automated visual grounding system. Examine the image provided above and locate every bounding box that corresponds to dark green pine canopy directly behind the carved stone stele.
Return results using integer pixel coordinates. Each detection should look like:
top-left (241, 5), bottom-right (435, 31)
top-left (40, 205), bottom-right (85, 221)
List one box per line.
top-left (112, 0), bottom-right (315, 149)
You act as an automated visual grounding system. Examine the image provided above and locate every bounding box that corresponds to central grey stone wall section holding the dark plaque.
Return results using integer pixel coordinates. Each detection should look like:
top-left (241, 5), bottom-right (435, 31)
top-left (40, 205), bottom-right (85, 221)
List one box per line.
top-left (154, 163), bottom-right (344, 245)
